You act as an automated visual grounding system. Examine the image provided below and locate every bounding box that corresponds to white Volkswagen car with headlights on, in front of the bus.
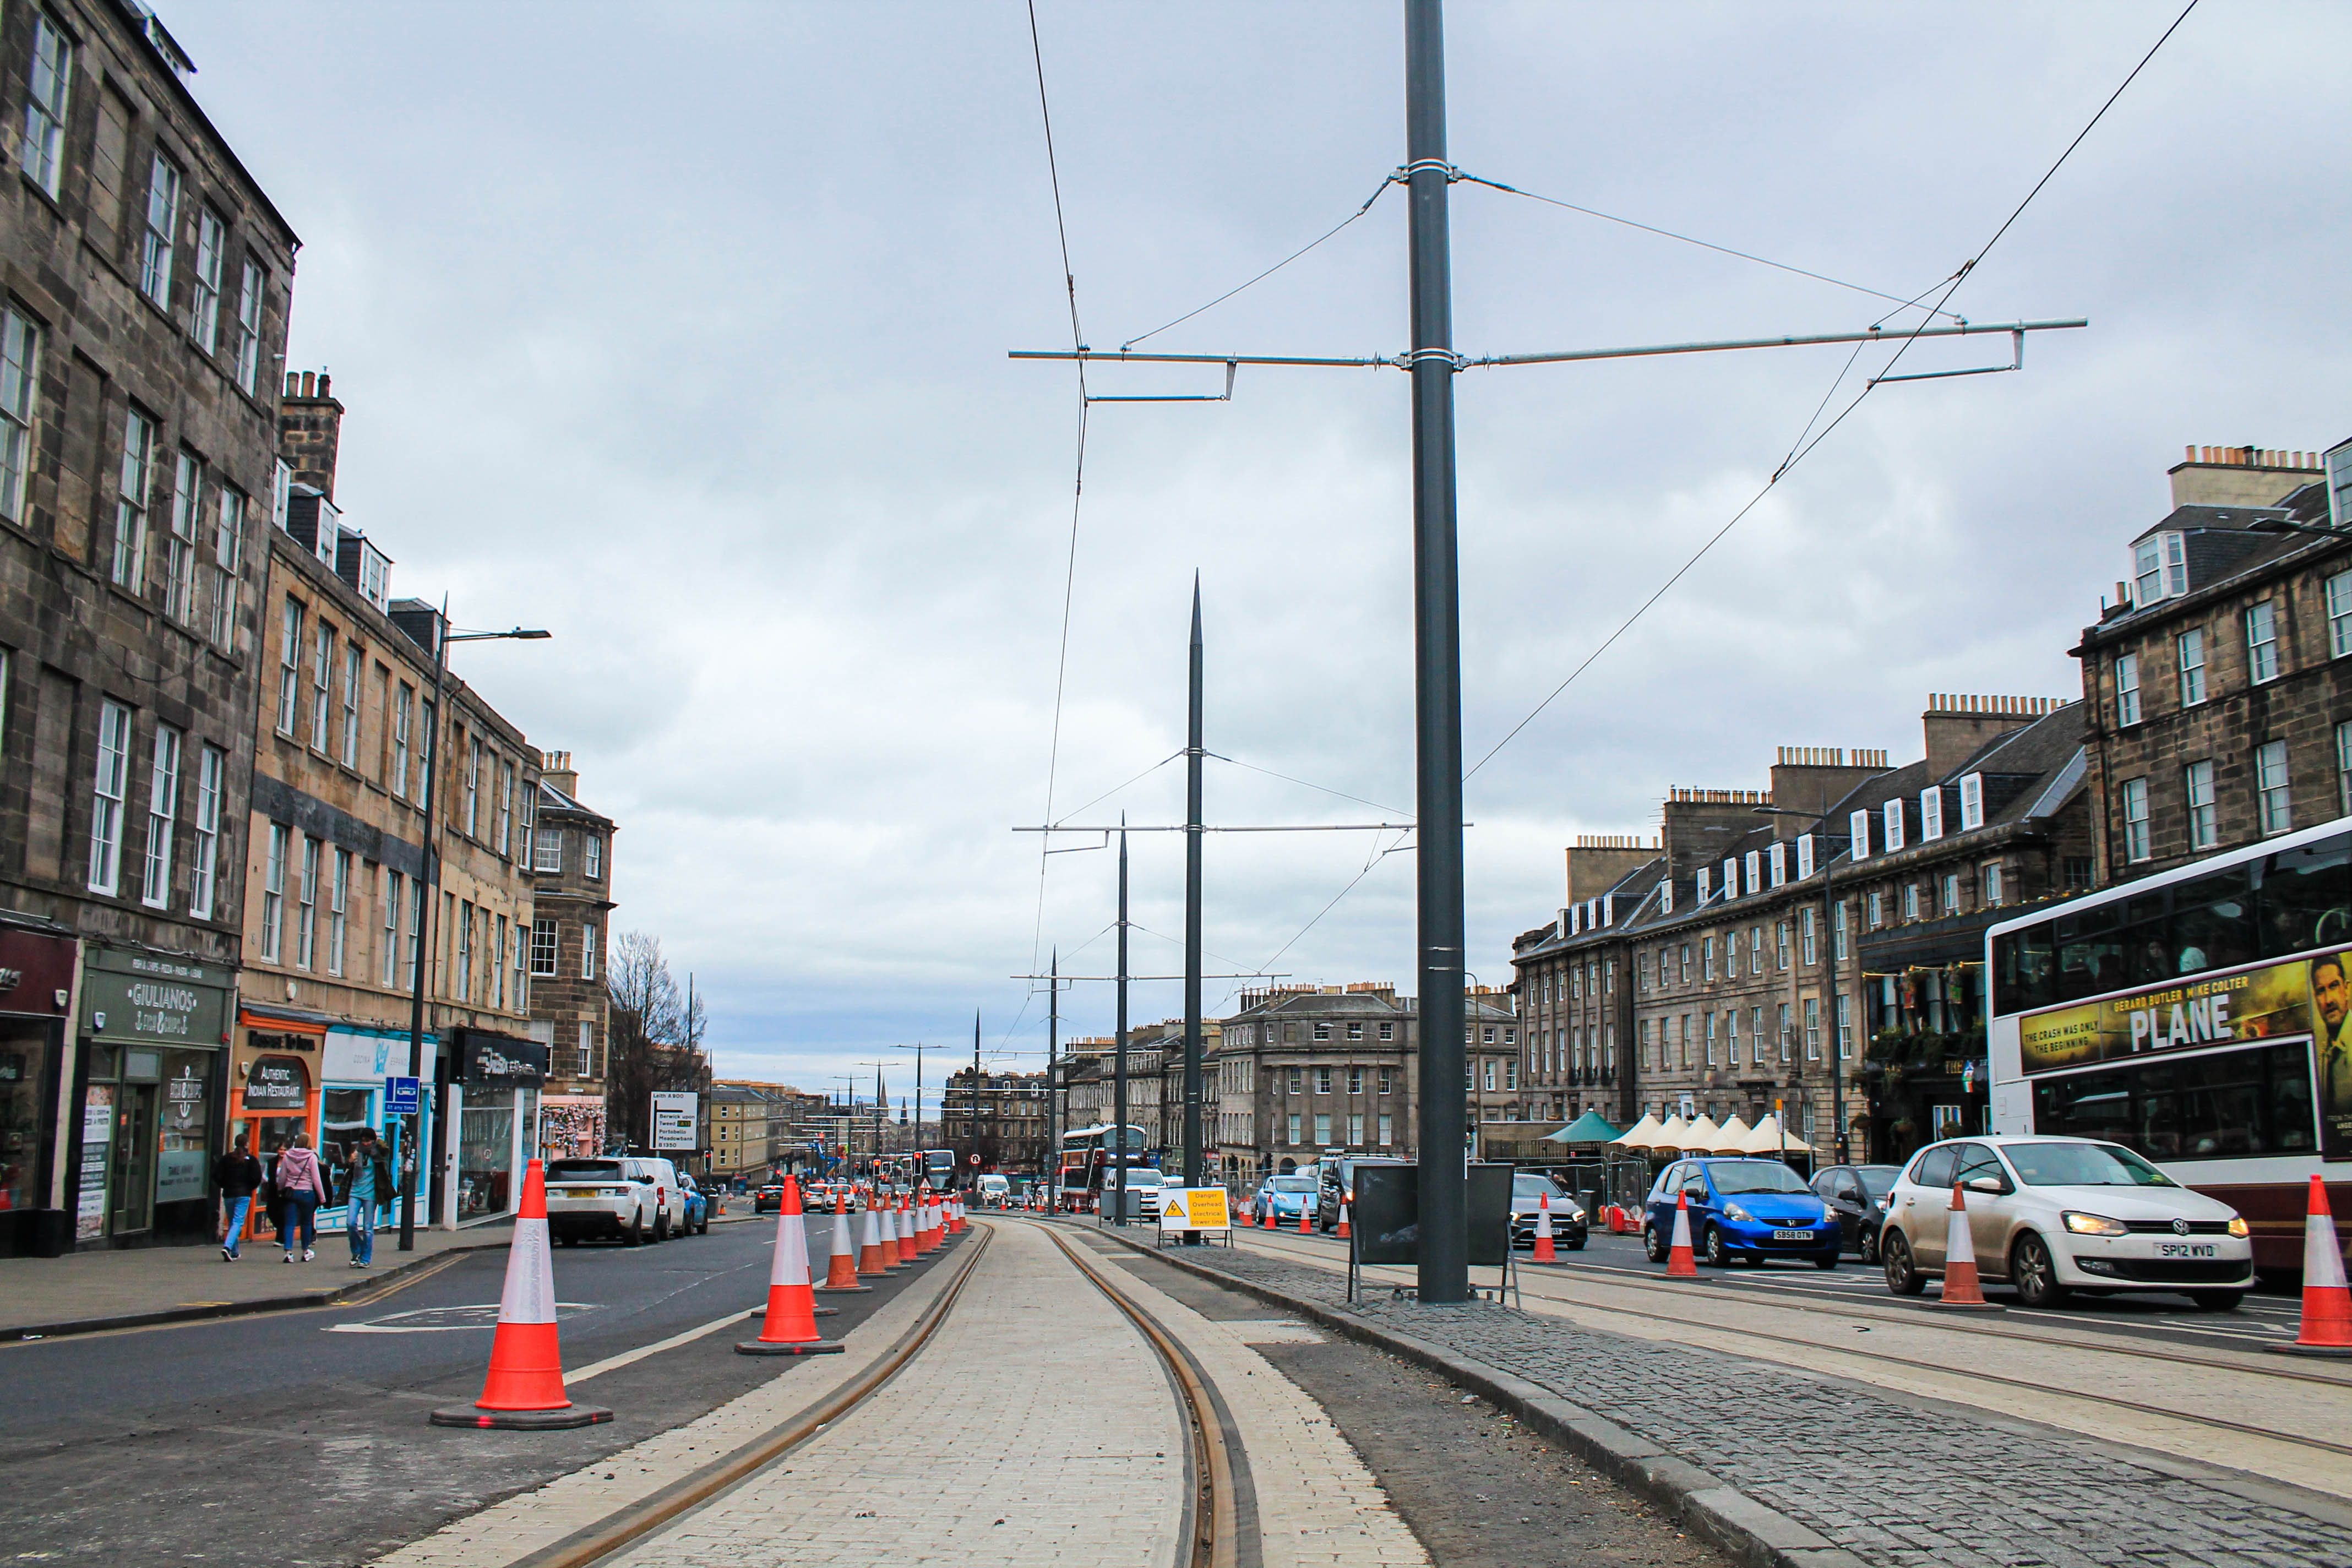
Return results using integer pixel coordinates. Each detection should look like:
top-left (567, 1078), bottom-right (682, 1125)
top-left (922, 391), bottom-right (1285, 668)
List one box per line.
top-left (1879, 1135), bottom-right (2253, 1312)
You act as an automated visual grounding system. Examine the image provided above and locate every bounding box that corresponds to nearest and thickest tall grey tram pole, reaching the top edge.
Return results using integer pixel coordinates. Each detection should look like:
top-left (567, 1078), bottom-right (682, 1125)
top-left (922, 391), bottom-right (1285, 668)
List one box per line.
top-left (1404, 0), bottom-right (1470, 1305)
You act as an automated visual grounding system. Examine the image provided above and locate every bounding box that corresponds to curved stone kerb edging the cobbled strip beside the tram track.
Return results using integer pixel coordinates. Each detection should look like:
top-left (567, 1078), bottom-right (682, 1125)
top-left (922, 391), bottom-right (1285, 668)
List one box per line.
top-left (1096, 1227), bottom-right (1863, 1568)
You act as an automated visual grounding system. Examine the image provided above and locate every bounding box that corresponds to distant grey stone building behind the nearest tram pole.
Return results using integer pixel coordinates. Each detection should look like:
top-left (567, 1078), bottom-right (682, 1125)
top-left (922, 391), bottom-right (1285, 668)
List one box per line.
top-left (1202, 983), bottom-right (1520, 1187)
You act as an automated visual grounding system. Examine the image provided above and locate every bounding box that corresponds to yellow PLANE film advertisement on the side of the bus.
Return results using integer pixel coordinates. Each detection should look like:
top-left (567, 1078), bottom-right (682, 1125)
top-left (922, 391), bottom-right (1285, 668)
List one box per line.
top-left (2018, 950), bottom-right (2352, 1159)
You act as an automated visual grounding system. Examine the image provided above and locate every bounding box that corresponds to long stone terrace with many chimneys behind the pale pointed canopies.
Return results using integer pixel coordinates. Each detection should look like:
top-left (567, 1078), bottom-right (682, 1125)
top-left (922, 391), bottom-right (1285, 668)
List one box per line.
top-left (1503, 696), bottom-right (2091, 1159)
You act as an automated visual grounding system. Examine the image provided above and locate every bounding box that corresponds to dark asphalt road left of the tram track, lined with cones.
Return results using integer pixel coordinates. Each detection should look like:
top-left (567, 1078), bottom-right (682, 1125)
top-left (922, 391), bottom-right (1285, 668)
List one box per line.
top-left (0, 1216), bottom-right (903, 1568)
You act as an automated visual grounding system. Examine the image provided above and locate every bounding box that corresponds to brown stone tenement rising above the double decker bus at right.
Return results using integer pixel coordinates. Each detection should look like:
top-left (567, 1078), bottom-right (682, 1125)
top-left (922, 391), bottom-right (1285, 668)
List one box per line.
top-left (2075, 442), bottom-right (2352, 881)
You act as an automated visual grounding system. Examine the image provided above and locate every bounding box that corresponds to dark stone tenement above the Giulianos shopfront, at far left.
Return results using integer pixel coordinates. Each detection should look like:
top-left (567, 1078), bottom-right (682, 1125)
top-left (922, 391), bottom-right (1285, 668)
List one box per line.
top-left (0, 0), bottom-right (299, 1253)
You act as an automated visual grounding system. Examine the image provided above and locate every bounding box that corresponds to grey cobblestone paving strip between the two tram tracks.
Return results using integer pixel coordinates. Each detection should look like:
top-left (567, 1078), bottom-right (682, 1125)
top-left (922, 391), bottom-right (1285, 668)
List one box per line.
top-left (1176, 1248), bottom-right (2352, 1568)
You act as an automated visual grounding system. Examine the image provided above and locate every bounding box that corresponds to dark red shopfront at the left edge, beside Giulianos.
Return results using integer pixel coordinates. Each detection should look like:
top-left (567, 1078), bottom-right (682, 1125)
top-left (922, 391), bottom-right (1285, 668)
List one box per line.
top-left (0, 926), bottom-right (75, 1257)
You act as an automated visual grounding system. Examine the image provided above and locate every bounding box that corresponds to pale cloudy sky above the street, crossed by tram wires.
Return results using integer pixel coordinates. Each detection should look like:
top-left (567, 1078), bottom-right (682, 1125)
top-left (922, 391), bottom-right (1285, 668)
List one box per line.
top-left (165, 0), bottom-right (2352, 1123)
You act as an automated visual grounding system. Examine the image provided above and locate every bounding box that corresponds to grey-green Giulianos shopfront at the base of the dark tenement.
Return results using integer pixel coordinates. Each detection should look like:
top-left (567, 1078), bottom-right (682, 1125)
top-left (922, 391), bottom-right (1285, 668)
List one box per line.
top-left (70, 948), bottom-right (235, 1248)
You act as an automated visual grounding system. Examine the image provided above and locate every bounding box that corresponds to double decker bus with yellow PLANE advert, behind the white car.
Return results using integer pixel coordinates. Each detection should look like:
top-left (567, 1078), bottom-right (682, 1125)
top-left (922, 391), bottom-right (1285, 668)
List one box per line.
top-left (1985, 820), bottom-right (2352, 1274)
